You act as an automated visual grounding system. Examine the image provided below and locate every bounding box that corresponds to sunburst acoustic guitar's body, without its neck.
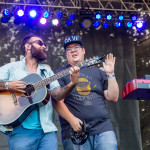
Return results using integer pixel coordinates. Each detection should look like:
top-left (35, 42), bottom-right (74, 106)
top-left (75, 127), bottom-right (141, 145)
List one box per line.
top-left (0, 74), bottom-right (50, 128)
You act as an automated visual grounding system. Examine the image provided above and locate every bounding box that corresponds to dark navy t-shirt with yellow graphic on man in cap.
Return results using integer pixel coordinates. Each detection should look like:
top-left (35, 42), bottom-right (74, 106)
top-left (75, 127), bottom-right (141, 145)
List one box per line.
top-left (58, 65), bottom-right (113, 140)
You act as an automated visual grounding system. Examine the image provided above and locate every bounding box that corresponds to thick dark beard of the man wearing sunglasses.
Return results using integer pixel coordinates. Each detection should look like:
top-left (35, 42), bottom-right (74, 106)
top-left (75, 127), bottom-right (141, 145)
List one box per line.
top-left (31, 46), bottom-right (47, 61)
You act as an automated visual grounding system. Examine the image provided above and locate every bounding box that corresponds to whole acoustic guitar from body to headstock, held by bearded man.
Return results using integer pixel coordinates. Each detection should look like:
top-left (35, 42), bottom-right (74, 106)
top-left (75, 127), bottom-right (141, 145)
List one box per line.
top-left (0, 55), bottom-right (104, 128)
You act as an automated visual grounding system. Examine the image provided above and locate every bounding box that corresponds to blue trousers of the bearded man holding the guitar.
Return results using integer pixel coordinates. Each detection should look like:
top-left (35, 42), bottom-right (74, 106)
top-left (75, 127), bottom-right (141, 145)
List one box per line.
top-left (8, 126), bottom-right (58, 150)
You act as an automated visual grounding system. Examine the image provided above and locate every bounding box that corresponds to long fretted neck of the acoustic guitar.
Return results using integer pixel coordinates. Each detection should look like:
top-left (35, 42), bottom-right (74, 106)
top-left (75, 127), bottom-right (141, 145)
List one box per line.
top-left (33, 63), bottom-right (83, 90)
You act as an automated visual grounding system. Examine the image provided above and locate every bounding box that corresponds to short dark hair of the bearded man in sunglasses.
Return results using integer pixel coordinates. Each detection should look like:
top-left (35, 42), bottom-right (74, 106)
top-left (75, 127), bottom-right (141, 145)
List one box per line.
top-left (21, 33), bottom-right (43, 56)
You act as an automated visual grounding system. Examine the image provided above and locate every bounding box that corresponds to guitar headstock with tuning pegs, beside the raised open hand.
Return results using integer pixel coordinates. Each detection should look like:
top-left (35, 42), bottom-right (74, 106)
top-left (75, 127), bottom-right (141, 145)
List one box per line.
top-left (81, 55), bottom-right (105, 67)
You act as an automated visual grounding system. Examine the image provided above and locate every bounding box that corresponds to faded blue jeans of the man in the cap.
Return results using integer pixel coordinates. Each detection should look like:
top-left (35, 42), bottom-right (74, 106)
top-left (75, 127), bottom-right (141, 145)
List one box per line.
top-left (63, 131), bottom-right (118, 150)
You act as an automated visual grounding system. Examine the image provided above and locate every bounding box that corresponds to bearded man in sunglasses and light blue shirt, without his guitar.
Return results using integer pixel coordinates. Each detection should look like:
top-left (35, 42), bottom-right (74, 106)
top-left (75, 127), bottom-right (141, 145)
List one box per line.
top-left (0, 34), bottom-right (80, 150)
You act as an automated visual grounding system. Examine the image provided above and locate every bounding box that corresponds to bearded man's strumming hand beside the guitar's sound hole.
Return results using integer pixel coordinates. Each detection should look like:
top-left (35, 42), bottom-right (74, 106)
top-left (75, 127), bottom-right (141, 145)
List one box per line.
top-left (0, 81), bottom-right (26, 93)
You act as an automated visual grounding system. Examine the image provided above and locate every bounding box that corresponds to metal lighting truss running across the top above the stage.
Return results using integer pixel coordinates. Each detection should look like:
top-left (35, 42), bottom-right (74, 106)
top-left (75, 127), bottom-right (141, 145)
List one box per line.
top-left (0, 0), bottom-right (150, 14)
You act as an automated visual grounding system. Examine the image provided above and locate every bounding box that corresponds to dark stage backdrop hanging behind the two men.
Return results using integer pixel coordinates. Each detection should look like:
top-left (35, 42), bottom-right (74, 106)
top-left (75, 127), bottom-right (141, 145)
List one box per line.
top-left (0, 23), bottom-right (142, 150)
